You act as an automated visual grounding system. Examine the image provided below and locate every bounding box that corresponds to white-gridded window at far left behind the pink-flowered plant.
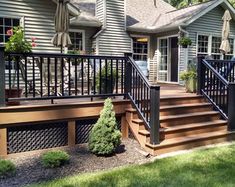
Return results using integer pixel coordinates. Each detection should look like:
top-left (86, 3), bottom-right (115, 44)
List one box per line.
top-left (0, 17), bottom-right (20, 43)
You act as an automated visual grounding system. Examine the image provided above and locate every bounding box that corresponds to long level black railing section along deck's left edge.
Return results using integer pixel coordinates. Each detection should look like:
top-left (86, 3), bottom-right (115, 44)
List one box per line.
top-left (5, 53), bottom-right (126, 100)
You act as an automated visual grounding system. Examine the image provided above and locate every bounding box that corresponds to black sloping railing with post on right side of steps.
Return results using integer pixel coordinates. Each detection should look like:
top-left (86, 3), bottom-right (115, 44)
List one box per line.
top-left (198, 58), bottom-right (235, 130)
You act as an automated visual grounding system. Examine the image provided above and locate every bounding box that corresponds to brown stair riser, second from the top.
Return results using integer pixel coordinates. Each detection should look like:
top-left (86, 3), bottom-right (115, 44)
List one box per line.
top-left (160, 106), bottom-right (213, 116)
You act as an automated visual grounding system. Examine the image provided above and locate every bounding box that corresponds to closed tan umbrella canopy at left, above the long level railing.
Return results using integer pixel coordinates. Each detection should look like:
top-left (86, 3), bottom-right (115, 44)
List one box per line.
top-left (51, 0), bottom-right (72, 49)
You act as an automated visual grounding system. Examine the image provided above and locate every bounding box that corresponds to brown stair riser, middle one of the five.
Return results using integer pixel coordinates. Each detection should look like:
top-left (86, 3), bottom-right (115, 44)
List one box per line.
top-left (160, 114), bottom-right (220, 127)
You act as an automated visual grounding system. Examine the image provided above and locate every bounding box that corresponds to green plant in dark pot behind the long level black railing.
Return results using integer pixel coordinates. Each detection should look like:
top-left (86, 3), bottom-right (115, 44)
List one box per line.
top-left (96, 63), bottom-right (117, 94)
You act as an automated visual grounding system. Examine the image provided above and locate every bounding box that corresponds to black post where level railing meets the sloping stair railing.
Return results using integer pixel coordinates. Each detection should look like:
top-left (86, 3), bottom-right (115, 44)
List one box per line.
top-left (124, 53), bottom-right (132, 99)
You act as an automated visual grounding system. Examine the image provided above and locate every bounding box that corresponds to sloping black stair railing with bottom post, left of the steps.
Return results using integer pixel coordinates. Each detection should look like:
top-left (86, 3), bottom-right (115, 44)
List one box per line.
top-left (125, 57), bottom-right (160, 144)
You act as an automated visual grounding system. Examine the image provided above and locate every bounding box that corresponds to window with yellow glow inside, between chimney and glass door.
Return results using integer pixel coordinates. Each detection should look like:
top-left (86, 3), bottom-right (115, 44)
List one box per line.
top-left (133, 37), bottom-right (148, 61)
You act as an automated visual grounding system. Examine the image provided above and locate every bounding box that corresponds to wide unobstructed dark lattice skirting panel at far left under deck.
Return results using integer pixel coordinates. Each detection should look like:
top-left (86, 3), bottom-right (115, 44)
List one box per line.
top-left (7, 122), bottom-right (68, 154)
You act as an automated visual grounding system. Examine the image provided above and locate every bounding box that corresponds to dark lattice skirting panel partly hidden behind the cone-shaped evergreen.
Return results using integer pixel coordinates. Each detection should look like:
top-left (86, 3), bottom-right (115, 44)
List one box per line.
top-left (76, 117), bottom-right (121, 144)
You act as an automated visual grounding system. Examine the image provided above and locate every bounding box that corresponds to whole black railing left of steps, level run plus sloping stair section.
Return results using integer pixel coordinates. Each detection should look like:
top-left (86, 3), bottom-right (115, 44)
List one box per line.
top-left (0, 48), bottom-right (160, 144)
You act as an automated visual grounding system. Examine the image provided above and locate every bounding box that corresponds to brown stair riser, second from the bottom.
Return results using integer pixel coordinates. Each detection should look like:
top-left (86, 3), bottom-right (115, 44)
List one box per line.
top-left (164, 125), bottom-right (227, 139)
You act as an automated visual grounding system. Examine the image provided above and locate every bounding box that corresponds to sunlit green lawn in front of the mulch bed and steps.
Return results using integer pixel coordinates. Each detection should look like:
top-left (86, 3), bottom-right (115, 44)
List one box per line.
top-left (31, 144), bottom-right (235, 187)
